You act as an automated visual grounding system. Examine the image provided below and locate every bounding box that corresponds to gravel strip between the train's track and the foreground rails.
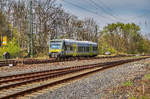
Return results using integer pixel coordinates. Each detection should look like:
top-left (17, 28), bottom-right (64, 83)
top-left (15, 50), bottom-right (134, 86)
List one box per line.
top-left (0, 57), bottom-right (133, 77)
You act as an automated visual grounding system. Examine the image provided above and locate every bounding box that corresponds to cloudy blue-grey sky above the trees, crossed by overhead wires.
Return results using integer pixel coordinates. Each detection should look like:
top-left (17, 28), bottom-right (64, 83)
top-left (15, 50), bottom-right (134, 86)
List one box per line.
top-left (58, 0), bottom-right (150, 33)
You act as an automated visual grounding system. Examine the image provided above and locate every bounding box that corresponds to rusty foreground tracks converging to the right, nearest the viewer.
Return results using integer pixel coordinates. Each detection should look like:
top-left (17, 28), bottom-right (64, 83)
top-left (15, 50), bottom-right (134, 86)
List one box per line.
top-left (0, 57), bottom-right (148, 99)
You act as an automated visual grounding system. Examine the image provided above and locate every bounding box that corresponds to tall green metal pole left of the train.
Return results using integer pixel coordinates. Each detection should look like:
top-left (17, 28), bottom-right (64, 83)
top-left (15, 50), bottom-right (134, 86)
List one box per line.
top-left (29, 0), bottom-right (33, 58)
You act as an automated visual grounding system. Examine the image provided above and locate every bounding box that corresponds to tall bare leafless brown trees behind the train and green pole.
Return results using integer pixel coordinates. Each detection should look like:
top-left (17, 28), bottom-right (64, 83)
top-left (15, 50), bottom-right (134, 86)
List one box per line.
top-left (0, 0), bottom-right (101, 55)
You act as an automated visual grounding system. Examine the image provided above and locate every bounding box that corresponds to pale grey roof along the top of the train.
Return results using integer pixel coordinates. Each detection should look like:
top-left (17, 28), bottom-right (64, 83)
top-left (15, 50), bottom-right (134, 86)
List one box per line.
top-left (51, 39), bottom-right (97, 45)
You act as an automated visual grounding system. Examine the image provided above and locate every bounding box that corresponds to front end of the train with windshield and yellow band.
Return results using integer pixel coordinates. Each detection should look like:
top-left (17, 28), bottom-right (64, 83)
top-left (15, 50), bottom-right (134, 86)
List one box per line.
top-left (49, 40), bottom-right (63, 58)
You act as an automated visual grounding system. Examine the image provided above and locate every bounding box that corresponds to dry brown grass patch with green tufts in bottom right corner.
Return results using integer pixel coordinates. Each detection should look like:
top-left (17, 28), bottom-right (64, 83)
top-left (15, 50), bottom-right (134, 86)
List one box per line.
top-left (103, 62), bottom-right (150, 99)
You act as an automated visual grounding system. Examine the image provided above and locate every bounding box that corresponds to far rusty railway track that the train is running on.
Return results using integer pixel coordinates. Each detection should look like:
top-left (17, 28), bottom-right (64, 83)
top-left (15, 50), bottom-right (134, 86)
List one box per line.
top-left (0, 55), bottom-right (137, 67)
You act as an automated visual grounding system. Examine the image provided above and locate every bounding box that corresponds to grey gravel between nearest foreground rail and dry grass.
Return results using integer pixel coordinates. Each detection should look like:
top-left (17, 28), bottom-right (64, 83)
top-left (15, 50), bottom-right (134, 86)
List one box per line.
top-left (30, 59), bottom-right (150, 99)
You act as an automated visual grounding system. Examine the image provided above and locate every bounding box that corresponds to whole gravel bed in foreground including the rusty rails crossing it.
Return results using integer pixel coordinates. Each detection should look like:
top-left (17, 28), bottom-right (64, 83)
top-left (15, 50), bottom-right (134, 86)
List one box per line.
top-left (0, 57), bottom-right (148, 99)
